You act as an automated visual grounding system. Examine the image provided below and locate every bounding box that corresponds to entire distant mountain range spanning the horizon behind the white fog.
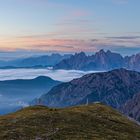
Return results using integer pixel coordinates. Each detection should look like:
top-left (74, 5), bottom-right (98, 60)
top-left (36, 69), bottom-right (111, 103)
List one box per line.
top-left (0, 50), bottom-right (140, 71)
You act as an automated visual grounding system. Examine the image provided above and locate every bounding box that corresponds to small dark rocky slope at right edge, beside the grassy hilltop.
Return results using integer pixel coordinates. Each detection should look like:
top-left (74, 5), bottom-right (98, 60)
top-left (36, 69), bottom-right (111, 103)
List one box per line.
top-left (121, 93), bottom-right (140, 122)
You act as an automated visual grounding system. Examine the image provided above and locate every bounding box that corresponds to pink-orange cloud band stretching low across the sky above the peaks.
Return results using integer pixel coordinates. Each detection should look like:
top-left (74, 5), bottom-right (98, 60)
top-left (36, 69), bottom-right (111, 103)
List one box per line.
top-left (0, 35), bottom-right (140, 52)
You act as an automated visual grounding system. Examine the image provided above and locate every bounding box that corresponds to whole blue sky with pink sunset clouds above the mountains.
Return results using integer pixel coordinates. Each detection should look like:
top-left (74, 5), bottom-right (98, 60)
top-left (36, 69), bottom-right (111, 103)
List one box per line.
top-left (0, 0), bottom-right (140, 57)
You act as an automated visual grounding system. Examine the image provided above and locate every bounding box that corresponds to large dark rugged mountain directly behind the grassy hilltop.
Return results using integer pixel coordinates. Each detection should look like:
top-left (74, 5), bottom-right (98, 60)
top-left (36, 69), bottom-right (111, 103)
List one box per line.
top-left (34, 69), bottom-right (140, 108)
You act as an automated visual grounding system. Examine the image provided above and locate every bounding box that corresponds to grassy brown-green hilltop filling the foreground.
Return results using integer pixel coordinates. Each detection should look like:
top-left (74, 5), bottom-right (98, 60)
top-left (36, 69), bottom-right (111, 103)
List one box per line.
top-left (0, 104), bottom-right (140, 140)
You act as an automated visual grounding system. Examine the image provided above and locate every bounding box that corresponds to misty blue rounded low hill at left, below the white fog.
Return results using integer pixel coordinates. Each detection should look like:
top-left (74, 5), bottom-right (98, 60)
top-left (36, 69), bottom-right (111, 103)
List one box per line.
top-left (0, 76), bottom-right (60, 114)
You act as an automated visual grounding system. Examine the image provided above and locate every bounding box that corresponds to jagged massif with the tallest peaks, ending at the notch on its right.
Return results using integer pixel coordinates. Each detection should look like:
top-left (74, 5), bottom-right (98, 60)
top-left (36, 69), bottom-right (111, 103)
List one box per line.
top-left (54, 50), bottom-right (124, 70)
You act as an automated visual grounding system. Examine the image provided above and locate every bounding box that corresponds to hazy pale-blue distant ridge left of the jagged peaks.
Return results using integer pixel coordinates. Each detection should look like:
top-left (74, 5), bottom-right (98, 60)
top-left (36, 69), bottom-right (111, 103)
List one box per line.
top-left (0, 54), bottom-right (71, 68)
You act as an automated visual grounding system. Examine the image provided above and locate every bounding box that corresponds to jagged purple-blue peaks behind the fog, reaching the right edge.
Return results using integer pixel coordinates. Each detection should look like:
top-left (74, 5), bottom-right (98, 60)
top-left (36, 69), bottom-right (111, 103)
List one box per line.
top-left (54, 50), bottom-right (140, 71)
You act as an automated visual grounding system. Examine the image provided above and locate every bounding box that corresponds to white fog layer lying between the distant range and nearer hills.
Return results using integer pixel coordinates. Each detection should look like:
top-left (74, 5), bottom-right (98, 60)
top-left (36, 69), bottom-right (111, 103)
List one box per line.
top-left (0, 69), bottom-right (101, 82)
